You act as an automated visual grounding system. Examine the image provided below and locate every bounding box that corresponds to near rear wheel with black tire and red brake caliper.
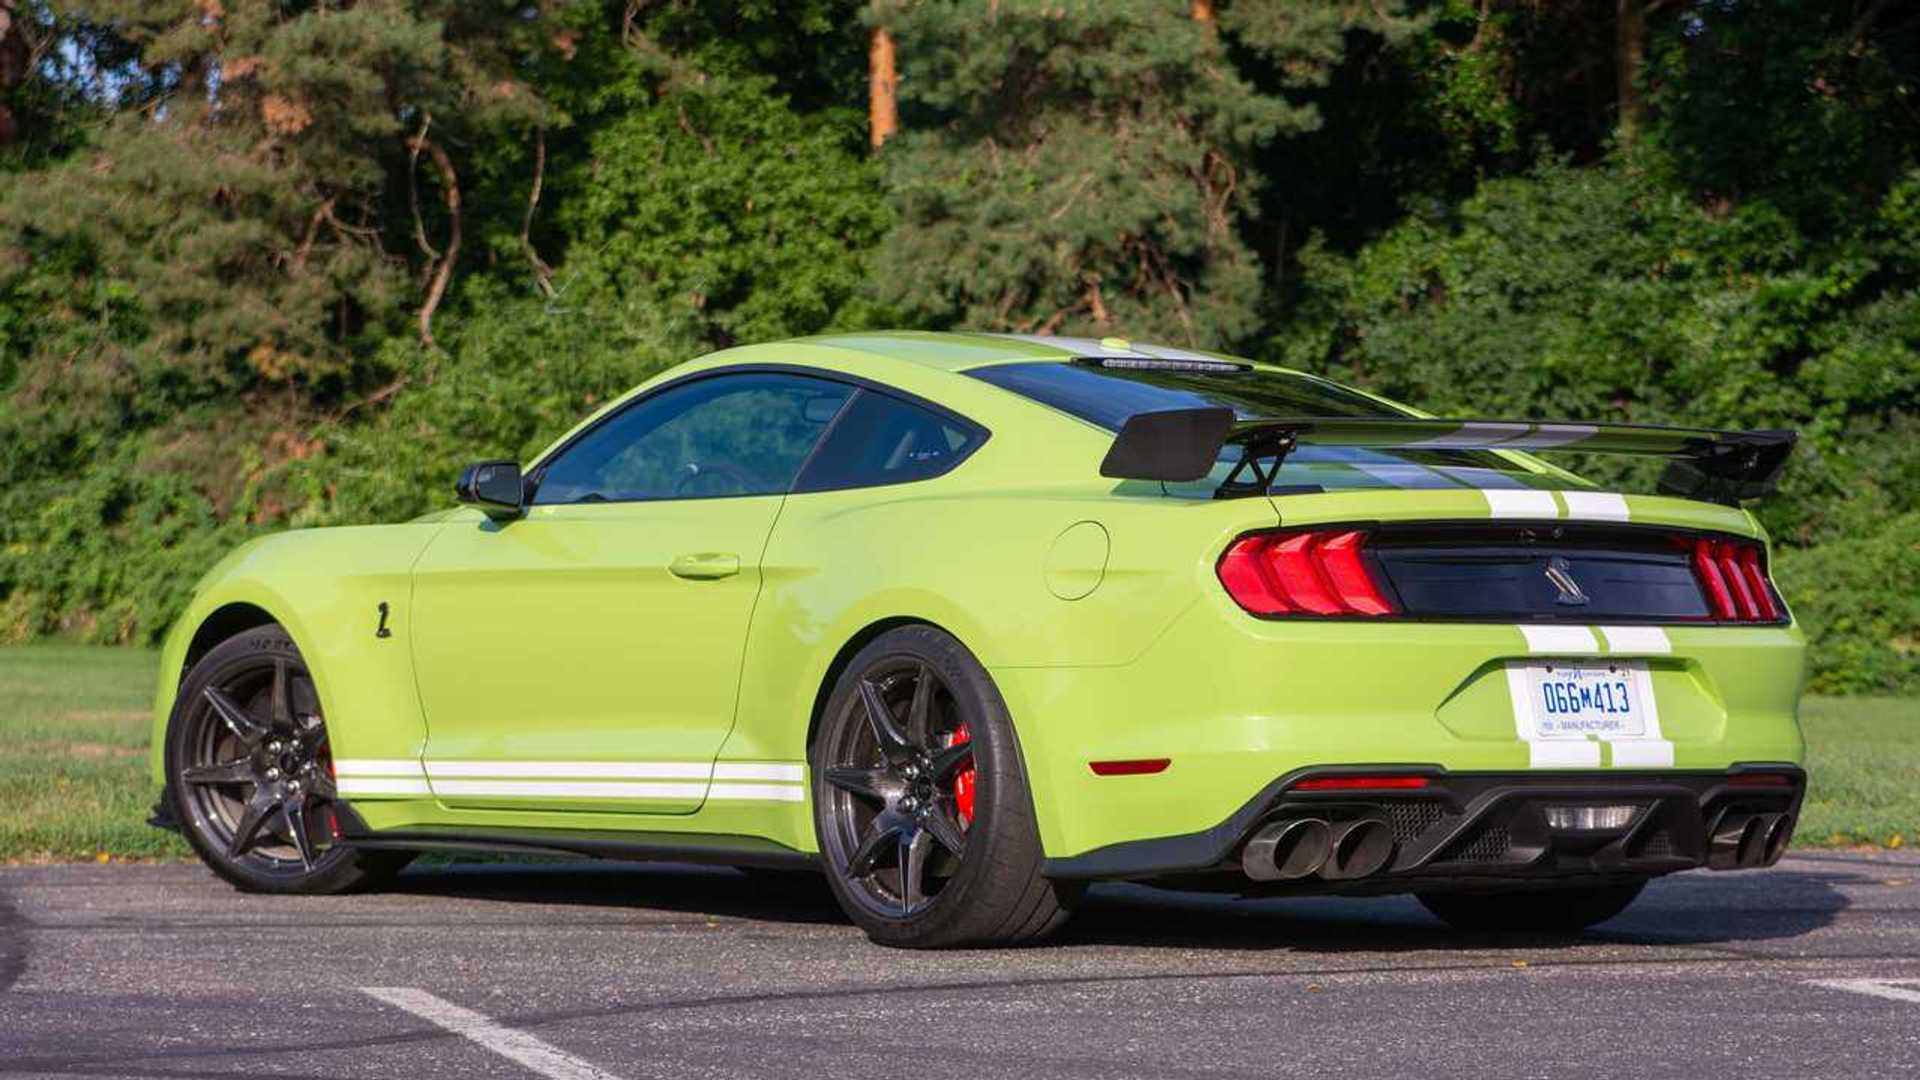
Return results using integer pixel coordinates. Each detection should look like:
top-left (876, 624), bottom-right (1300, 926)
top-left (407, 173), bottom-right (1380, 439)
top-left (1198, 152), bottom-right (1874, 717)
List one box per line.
top-left (810, 626), bottom-right (1083, 949)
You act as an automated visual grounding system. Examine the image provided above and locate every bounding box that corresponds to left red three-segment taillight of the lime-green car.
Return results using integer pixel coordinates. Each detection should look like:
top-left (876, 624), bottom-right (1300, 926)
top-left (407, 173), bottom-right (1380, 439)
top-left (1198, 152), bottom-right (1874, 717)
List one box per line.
top-left (1217, 528), bottom-right (1396, 617)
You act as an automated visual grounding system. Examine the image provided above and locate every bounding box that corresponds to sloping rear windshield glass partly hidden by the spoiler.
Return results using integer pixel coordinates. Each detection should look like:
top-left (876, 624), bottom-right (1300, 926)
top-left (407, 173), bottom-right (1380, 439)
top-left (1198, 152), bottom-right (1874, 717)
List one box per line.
top-left (968, 361), bottom-right (1576, 492)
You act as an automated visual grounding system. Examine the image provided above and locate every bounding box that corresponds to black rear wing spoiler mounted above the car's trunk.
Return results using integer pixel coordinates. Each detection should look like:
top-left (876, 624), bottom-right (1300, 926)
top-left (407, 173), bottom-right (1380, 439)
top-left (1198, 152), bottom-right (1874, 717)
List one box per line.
top-left (1100, 407), bottom-right (1799, 505)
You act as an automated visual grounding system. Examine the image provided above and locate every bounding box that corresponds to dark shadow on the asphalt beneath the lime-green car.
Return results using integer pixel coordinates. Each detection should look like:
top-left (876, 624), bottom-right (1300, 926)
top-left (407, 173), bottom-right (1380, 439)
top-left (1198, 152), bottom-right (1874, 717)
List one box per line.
top-left (390, 861), bottom-right (1850, 951)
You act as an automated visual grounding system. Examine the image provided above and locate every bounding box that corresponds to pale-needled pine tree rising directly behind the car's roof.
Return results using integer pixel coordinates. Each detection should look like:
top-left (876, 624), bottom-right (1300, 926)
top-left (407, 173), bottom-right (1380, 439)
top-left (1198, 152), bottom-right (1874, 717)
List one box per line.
top-left (874, 0), bottom-right (1398, 346)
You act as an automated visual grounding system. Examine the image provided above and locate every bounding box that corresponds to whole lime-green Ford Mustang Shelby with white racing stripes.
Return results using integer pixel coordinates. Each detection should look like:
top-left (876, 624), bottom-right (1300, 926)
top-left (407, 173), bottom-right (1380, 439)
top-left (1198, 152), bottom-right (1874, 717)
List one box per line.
top-left (154, 332), bottom-right (1805, 945)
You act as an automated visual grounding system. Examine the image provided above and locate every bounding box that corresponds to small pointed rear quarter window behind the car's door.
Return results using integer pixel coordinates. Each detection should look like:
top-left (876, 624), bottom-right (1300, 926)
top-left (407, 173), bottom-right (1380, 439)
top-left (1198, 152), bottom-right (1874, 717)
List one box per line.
top-left (793, 390), bottom-right (987, 492)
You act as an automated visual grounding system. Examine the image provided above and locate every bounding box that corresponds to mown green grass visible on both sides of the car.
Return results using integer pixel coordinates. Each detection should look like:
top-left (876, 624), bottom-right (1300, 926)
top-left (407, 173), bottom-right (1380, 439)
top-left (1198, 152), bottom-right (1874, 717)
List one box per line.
top-left (0, 646), bottom-right (1920, 861)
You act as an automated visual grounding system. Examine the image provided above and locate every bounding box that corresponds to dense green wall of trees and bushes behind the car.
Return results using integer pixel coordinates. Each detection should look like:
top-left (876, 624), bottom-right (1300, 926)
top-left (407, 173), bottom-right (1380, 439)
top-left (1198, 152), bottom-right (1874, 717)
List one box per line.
top-left (0, 0), bottom-right (1920, 690)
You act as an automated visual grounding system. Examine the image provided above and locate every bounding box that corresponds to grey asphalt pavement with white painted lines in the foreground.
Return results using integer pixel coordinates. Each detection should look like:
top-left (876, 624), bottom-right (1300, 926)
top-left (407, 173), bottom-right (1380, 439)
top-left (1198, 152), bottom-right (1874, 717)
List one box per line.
top-left (0, 851), bottom-right (1920, 1080)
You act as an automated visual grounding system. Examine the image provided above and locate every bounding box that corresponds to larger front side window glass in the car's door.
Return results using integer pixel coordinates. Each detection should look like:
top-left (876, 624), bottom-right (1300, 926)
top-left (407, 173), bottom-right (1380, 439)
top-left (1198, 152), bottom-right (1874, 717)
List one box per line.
top-left (534, 373), bottom-right (852, 505)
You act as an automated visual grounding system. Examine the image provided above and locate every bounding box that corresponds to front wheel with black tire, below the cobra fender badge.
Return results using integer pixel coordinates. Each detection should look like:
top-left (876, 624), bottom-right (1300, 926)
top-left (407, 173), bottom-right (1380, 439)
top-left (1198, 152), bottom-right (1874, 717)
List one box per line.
top-left (167, 625), bottom-right (413, 896)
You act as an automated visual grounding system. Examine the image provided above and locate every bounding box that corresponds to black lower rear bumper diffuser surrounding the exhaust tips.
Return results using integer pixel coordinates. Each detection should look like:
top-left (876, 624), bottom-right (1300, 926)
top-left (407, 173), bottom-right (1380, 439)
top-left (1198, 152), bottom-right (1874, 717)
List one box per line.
top-left (1046, 763), bottom-right (1807, 894)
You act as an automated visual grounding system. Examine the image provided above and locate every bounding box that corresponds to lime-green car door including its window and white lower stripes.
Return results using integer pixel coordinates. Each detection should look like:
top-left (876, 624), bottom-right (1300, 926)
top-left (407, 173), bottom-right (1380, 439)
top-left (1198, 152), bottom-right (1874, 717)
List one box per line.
top-left (413, 371), bottom-right (852, 813)
